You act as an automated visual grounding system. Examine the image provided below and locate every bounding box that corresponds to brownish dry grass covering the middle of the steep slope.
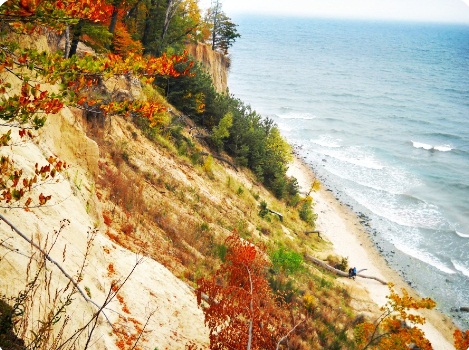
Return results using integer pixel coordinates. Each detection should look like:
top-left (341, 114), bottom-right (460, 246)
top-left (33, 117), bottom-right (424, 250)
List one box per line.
top-left (83, 102), bottom-right (353, 349)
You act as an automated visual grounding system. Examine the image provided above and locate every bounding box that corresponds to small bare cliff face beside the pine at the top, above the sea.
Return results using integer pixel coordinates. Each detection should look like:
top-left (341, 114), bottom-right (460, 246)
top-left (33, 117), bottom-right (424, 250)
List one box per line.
top-left (186, 43), bottom-right (230, 92)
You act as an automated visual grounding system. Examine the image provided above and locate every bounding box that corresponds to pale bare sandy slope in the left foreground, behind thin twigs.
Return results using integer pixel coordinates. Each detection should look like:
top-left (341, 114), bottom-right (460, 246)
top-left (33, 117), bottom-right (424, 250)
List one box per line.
top-left (0, 104), bottom-right (208, 349)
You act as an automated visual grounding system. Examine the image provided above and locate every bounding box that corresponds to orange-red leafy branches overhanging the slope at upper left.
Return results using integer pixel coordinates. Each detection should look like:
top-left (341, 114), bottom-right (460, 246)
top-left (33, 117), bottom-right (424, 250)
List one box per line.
top-left (0, 0), bottom-right (190, 210)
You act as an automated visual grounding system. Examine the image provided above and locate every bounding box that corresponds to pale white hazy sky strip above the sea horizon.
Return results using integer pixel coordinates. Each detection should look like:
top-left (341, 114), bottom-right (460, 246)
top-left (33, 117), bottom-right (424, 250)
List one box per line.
top-left (200, 0), bottom-right (469, 23)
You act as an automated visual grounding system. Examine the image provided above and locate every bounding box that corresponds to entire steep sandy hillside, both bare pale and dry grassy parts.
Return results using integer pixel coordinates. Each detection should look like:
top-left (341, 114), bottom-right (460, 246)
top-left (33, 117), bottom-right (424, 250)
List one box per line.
top-left (0, 30), bottom-right (376, 349)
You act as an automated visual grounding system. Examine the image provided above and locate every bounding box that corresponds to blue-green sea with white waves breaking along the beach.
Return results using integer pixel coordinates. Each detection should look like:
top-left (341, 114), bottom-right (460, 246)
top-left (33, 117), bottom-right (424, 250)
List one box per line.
top-left (228, 16), bottom-right (469, 329)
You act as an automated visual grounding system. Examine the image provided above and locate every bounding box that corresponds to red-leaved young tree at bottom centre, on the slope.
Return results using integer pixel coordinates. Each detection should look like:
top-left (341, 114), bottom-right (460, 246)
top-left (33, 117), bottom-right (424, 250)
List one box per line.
top-left (197, 234), bottom-right (296, 350)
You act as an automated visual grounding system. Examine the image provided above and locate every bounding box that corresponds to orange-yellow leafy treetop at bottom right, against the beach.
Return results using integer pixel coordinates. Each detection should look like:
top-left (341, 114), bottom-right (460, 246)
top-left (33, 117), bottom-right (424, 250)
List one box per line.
top-left (355, 284), bottom-right (436, 350)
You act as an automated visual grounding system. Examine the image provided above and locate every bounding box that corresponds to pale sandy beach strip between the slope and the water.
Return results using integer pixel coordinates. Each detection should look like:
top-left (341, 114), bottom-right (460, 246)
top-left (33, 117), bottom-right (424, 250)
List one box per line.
top-left (287, 154), bottom-right (457, 350)
